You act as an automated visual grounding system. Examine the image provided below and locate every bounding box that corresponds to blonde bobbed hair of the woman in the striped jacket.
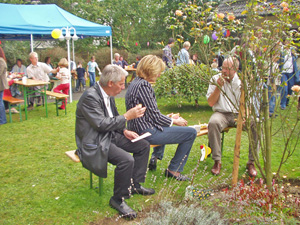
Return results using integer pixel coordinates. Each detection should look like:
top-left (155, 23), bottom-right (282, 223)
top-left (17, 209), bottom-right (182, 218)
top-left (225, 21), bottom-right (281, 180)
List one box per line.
top-left (136, 55), bottom-right (165, 80)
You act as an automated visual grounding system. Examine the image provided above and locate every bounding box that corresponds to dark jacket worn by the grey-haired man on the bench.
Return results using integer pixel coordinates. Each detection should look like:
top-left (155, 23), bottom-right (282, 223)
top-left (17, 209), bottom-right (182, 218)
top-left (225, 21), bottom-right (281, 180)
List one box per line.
top-left (75, 84), bottom-right (126, 177)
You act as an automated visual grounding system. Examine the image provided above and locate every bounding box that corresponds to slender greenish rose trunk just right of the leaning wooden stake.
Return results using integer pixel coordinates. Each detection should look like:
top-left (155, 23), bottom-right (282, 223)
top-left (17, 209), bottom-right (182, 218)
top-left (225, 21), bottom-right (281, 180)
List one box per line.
top-left (263, 88), bottom-right (272, 191)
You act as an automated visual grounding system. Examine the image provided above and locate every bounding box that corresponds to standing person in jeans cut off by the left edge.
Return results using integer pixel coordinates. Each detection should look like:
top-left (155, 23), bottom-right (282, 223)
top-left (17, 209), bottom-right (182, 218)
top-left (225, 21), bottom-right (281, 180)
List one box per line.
top-left (0, 47), bottom-right (8, 125)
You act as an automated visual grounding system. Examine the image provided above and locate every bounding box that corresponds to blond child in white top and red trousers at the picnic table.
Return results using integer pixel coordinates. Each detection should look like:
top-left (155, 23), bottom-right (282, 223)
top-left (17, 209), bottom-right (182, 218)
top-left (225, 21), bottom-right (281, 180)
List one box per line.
top-left (53, 58), bottom-right (71, 109)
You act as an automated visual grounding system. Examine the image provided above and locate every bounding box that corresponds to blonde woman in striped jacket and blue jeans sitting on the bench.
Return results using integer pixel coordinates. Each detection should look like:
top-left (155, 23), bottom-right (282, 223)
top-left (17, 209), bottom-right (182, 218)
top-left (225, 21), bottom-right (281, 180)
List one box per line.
top-left (125, 55), bottom-right (197, 181)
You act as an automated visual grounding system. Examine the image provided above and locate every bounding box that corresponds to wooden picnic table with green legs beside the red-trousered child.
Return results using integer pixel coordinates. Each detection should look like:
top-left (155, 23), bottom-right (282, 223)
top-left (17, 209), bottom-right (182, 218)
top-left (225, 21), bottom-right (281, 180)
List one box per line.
top-left (15, 79), bottom-right (49, 120)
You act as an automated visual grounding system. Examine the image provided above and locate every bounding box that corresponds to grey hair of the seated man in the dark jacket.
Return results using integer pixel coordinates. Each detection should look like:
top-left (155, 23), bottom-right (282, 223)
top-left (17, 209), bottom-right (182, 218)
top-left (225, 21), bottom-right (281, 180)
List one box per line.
top-left (99, 64), bottom-right (128, 87)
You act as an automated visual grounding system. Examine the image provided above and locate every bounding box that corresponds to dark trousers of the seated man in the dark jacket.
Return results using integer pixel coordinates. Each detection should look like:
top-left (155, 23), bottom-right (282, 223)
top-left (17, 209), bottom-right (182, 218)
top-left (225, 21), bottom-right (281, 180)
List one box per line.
top-left (108, 133), bottom-right (150, 199)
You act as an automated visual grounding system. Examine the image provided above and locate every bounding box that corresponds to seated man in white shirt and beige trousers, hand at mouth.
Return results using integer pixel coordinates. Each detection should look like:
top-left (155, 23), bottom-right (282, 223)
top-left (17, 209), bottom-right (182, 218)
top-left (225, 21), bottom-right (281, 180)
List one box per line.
top-left (206, 57), bottom-right (257, 177)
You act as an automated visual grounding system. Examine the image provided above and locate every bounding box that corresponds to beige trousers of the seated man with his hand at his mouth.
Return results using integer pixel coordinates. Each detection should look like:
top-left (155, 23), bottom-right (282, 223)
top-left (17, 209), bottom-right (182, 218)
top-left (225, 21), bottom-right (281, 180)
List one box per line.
top-left (208, 112), bottom-right (259, 162)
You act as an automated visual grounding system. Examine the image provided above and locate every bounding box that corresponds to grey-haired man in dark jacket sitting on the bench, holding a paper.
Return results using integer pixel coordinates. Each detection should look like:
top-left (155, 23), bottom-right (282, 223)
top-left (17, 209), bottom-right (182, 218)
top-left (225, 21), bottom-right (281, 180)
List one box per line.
top-left (76, 65), bottom-right (155, 218)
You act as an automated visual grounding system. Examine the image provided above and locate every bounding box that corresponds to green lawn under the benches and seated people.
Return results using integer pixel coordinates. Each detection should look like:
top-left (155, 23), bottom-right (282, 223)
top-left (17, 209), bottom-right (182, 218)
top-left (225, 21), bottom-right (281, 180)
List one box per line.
top-left (0, 95), bottom-right (300, 224)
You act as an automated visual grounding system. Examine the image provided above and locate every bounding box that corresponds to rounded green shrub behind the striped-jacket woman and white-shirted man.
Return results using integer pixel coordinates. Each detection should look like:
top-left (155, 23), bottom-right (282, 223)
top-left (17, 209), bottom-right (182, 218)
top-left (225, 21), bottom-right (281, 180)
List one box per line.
top-left (155, 64), bottom-right (212, 104)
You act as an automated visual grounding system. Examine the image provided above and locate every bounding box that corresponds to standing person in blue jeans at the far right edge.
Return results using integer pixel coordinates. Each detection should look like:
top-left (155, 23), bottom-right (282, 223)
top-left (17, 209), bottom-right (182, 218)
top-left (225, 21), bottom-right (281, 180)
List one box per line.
top-left (279, 40), bottom-right (300, 110)
